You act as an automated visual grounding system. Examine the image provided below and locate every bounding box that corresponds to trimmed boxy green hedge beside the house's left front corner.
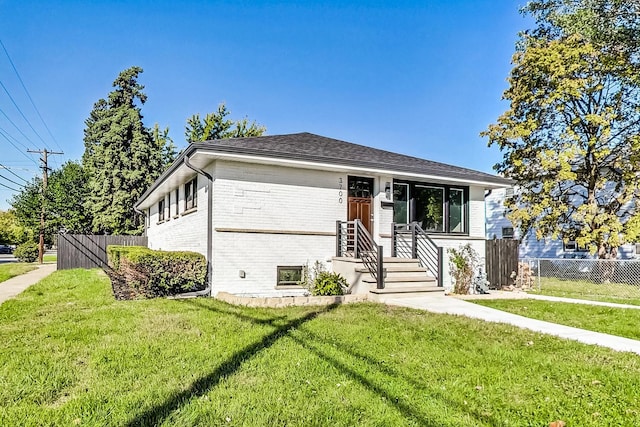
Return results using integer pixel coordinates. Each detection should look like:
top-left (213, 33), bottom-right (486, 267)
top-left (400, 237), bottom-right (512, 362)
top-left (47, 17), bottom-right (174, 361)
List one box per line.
top-left (107, 245), bottom-right (207, 298)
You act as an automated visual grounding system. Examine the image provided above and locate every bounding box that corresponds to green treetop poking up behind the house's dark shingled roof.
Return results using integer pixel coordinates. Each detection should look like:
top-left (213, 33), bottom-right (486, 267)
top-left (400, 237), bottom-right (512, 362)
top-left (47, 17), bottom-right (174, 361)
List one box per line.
top-left (185, 103), bottom-right (267, 142)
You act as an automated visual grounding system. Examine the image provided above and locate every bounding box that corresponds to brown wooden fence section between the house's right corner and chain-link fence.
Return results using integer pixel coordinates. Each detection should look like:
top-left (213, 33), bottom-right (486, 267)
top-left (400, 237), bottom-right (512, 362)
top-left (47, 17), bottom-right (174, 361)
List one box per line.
top-left (485, 239), bottom-right (518, 289)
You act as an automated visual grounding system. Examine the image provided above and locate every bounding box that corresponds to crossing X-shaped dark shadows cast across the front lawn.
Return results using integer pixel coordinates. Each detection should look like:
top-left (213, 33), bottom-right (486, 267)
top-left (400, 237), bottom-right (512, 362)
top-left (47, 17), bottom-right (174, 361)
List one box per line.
top-left (127, 300), bottom-right (501, 427)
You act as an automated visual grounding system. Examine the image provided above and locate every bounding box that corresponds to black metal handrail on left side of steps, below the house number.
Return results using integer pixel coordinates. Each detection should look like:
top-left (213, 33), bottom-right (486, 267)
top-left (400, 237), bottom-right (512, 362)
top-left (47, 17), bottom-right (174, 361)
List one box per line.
top-left (336, 219), bottom-right (384, 289)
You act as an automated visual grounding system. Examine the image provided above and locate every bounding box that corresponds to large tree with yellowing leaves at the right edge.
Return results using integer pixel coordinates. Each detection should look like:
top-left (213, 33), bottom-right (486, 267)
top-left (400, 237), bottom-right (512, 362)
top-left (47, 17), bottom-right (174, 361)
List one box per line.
top-left (482, 0), bottom-right (640, 258)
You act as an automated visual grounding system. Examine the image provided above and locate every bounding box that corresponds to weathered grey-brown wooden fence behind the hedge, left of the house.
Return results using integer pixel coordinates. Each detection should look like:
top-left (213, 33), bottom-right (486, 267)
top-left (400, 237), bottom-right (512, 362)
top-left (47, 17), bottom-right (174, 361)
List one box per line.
top-left (58, 234), bottom-right (147, 270)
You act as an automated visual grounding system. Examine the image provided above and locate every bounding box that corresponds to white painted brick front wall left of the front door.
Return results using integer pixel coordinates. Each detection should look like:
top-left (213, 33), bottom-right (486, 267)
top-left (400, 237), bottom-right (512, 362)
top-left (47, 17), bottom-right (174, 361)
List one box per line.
top-left (213, 161), bottom-right (347, 294)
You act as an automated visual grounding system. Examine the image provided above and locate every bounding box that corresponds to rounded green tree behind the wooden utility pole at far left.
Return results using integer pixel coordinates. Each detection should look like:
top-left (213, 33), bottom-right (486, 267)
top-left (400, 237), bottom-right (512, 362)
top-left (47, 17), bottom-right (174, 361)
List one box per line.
top-left (11, 161), bottom-right (91, 243)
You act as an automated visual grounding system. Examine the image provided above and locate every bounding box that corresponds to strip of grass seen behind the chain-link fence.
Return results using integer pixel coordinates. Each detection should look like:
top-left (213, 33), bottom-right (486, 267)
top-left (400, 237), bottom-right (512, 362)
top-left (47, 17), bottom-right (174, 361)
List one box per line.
top-left (531, 277), bottom-right (640, 305)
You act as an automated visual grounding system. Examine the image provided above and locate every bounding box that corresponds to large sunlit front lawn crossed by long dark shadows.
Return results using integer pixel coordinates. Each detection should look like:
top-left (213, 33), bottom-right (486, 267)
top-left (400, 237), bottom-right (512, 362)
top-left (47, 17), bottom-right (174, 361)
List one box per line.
top-left (0, 270), bottom-right (640, 426)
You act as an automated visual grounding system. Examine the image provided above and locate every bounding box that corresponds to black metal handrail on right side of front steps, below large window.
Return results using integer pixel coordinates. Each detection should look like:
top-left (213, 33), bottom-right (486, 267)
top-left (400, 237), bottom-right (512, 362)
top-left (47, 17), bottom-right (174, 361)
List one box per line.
top-left (391, 222), bottom-right (443, 286)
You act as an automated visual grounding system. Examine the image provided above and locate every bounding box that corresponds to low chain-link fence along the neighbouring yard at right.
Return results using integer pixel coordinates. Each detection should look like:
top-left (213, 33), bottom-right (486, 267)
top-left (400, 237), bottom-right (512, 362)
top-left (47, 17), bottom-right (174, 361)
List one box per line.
top-left (514, 258), bottom-right (640, 303)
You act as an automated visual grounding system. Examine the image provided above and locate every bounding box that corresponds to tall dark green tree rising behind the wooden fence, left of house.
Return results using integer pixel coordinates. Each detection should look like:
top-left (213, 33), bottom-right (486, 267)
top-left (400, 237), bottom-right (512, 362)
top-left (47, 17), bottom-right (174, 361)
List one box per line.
top-left (82, 67), bottom-right (172, 234)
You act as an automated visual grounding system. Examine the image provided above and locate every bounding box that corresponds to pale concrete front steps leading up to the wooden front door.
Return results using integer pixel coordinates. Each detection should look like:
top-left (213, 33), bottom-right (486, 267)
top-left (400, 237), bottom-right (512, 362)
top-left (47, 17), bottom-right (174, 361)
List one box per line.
top-left (332, 257), bottom-right (443, 296)
